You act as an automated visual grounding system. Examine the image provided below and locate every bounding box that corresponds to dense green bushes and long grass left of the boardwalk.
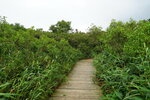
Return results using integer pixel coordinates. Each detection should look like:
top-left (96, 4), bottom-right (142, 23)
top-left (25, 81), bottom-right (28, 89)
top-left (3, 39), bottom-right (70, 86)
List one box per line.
top-left (0, 18), bottom-right (82, 100)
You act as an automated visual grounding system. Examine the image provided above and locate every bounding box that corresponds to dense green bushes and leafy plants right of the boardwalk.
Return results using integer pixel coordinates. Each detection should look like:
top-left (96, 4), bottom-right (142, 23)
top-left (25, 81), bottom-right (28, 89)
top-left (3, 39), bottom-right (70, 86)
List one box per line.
top-left (94, 20), bottom-right (150, 100)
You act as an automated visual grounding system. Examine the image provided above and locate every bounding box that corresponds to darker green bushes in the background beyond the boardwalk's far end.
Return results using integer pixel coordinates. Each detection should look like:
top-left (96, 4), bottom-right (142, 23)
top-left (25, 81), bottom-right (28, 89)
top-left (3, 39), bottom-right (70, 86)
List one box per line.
top-left (47, 32), bottom-right (103, 58)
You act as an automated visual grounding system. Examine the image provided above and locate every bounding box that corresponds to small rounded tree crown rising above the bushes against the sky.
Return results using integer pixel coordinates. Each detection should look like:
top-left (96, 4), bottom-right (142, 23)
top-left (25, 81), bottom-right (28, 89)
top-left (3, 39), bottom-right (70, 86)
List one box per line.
top-left (49, 20), bottom-right (72, 33)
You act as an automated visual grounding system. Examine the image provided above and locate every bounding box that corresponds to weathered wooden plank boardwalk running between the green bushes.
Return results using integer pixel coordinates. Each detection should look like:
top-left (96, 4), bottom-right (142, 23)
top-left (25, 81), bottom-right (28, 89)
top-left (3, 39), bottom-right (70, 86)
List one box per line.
top-left (49, 59), bottom-right (101, 100)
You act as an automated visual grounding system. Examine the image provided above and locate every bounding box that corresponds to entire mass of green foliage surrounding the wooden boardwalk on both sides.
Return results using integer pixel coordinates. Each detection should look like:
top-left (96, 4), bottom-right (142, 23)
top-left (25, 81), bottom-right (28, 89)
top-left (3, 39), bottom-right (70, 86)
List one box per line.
top-left (0, 17), bottom-right (150, 100)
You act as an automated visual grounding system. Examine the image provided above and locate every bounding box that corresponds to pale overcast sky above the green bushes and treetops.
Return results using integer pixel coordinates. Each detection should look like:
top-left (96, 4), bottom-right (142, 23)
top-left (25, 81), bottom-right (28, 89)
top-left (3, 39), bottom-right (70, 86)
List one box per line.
top-left (0, 0), bottom-right (150, 31)
